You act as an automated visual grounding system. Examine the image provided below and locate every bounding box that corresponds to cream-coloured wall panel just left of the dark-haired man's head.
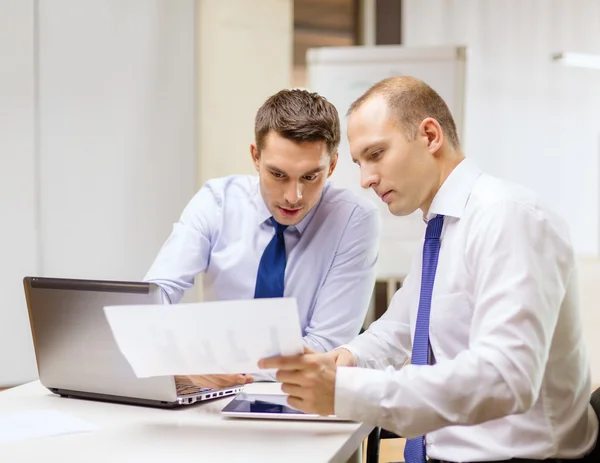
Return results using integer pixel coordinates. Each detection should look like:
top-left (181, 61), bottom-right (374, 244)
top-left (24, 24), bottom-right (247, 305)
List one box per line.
top-left (197, 0), bottom-right (293, 183)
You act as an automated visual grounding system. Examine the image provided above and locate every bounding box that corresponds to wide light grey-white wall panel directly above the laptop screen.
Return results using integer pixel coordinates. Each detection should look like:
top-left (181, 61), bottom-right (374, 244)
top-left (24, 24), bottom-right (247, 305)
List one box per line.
top-left (39, 0), bottom-right (196, 280)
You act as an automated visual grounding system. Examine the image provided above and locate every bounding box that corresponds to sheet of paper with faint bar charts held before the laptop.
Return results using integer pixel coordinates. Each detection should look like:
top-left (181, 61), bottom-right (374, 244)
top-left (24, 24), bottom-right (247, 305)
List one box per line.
top-left (104, 298), bottom-right (304, 378)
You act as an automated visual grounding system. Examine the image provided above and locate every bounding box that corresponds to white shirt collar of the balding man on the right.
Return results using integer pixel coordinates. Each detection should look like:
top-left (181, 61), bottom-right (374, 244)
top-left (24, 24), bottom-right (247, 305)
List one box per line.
top-left (426, 159), bottom-right (481, 220)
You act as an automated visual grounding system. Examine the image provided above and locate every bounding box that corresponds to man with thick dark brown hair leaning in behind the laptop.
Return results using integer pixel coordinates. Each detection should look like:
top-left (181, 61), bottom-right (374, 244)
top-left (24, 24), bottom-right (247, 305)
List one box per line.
top-left (145, 90), bottom-right (380, 387)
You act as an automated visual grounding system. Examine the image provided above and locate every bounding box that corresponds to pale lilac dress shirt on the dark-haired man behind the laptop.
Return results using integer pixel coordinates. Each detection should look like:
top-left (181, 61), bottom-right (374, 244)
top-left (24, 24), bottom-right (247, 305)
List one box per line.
top-left (145, 176), bottom-right (380, 352)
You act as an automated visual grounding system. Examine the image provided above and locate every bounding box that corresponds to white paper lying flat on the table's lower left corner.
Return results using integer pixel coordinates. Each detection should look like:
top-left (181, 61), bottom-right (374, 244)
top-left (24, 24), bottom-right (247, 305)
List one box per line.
top-left (0, 410), bottom-right (96, 444)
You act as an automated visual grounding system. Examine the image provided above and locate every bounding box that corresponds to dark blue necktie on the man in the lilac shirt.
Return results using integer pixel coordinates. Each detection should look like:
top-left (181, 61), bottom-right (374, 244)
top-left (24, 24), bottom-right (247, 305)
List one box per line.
top-left (254, 217), bottom-right (287, 299)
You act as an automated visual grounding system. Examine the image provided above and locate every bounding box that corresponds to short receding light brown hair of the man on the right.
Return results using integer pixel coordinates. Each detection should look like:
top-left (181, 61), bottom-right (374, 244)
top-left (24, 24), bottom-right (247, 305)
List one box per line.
top-left (348, 76), bottom-right (460, 148)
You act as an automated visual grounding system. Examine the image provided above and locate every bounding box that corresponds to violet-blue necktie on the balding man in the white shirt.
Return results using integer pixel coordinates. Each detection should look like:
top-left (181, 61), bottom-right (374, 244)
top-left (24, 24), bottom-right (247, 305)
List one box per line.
top-left (404, 215), bottom-right (444, 463)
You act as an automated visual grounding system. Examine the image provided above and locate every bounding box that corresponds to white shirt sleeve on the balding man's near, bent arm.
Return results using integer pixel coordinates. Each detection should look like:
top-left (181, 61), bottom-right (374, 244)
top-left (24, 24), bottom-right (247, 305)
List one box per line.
top-left (335, 203), bottom-right (574, 438)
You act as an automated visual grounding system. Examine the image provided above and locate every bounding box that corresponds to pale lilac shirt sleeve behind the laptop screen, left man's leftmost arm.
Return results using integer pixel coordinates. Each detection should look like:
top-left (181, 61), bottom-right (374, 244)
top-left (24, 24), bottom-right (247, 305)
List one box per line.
top-left (144, 185), bottom-right (221, 304)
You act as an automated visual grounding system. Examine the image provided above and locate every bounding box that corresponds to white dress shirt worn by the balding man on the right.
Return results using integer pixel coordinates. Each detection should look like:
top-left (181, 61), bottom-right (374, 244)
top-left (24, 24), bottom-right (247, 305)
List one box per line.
top-left (335, 160), bottom-right (598, 461)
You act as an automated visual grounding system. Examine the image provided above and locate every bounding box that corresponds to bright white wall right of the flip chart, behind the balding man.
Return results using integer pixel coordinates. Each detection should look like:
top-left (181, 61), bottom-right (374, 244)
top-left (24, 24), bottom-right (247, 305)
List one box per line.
top-left (402, 0), bottom-right (600, 385)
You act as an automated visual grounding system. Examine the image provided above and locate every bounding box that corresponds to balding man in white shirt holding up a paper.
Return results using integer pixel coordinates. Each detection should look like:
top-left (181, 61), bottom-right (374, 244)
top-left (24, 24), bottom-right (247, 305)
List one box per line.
top-left (260, 77), bottom-right (598, 463)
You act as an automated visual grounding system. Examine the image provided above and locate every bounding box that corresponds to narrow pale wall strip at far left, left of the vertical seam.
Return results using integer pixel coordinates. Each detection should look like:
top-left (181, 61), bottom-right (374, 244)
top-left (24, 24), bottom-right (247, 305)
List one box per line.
top-left (0, 0), bottom-right (39, 386)
